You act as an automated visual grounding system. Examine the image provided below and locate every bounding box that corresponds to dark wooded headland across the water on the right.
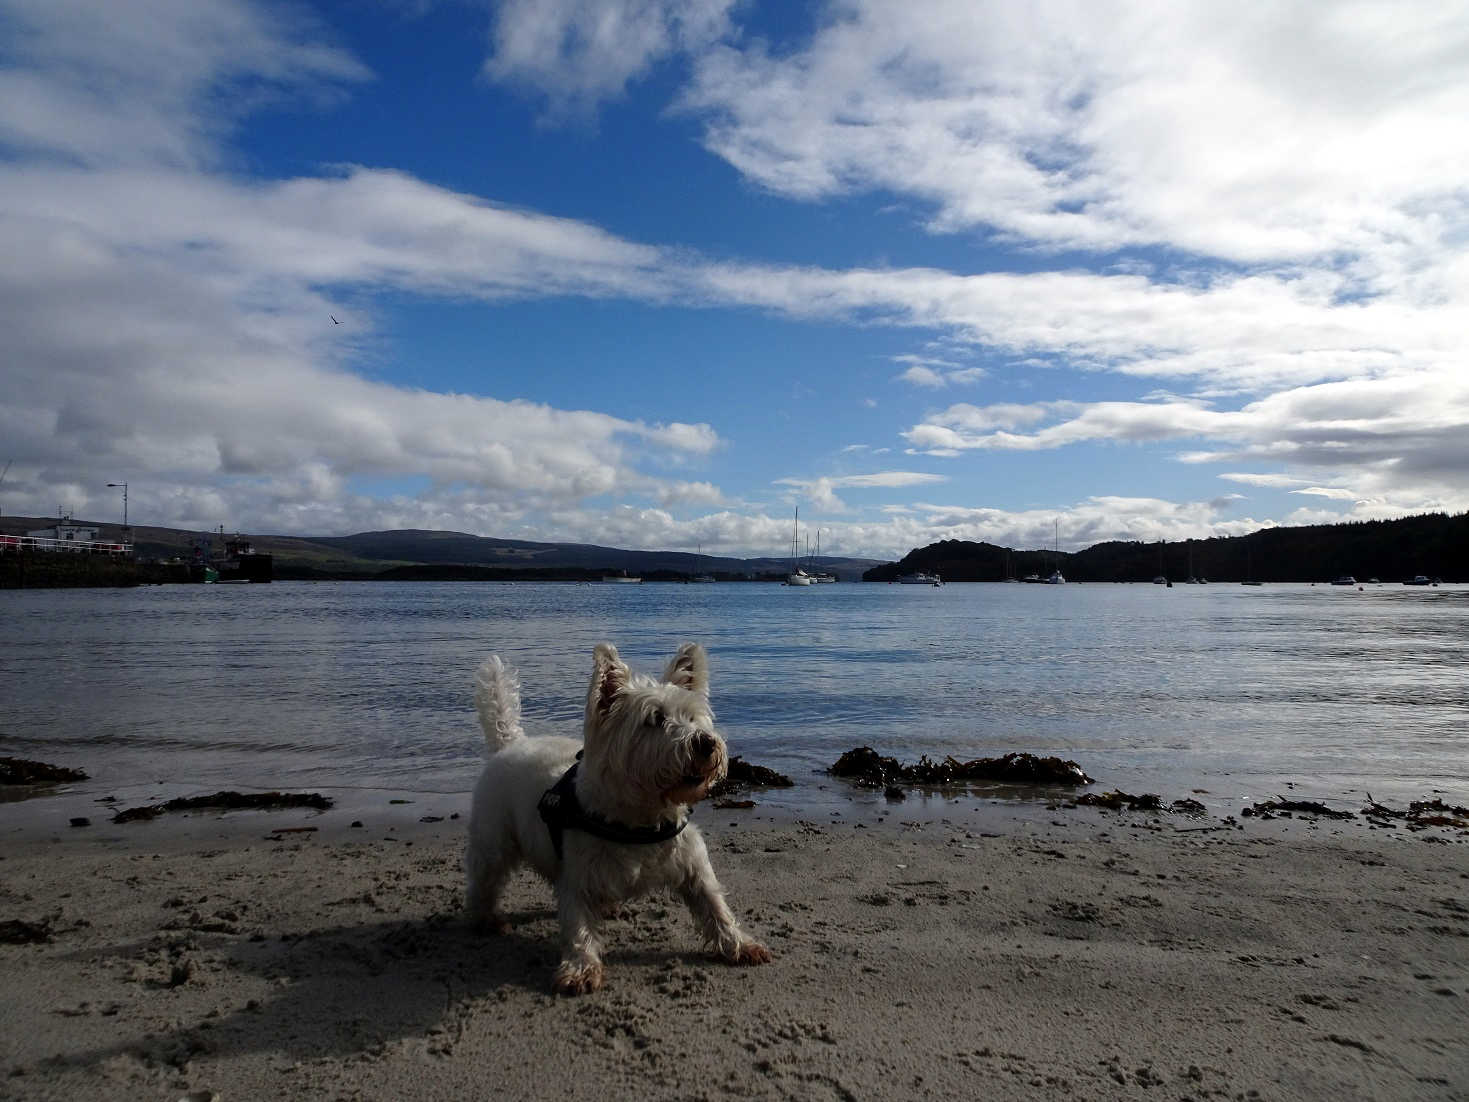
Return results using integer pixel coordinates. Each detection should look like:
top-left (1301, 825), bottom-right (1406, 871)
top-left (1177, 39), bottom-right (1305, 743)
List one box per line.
top-left (862, 513), bottom-right (1469, 582)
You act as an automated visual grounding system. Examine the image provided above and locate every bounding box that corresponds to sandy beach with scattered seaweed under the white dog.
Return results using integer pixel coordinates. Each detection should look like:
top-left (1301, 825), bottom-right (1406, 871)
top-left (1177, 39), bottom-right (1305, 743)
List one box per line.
top-left (0, 804), bottom-right (1469, 1102)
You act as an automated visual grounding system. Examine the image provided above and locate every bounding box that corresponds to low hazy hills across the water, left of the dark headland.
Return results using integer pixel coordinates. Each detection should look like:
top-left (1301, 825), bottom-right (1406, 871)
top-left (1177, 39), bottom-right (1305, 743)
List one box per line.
top-left (0, 517), bottom-right (877, 582)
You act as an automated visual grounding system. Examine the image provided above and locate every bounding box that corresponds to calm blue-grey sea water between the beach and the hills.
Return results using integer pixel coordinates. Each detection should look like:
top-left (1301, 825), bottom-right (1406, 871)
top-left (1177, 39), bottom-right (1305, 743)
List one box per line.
top-left (0, 582), bottom-right (1469, 815)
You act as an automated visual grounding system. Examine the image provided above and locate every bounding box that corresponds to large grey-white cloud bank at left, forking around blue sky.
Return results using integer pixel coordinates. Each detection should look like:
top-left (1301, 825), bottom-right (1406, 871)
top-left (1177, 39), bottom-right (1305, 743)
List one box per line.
top-left (0, 158), bottom-right (720, 523)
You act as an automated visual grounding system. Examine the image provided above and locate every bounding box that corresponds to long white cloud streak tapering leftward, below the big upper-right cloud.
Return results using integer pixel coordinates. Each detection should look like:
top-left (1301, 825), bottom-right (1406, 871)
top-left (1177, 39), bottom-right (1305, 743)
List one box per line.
top-left (686, 264), bottom-right (1469, 392)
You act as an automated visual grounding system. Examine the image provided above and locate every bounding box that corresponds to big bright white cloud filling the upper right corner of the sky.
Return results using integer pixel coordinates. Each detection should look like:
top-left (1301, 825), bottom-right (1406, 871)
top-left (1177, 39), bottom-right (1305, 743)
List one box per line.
top-left (685, 0), bottom-right (1469, 276)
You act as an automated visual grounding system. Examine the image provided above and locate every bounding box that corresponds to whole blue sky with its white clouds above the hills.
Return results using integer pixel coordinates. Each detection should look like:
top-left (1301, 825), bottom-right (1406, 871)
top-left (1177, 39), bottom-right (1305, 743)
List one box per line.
top-left (0, 0), bottom-right (1469, 557)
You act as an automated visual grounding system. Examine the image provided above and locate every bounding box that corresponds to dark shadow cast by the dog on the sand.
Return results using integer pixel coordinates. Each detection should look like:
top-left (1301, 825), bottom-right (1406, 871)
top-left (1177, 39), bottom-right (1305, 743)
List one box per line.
top-left (58, 911), bottom-right (722, 1068)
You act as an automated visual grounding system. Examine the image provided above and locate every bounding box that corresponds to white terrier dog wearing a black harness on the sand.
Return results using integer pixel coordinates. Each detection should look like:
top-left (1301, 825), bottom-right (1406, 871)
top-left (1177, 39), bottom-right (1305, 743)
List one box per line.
top-left (464, 644), bottom-right (771, 995)
